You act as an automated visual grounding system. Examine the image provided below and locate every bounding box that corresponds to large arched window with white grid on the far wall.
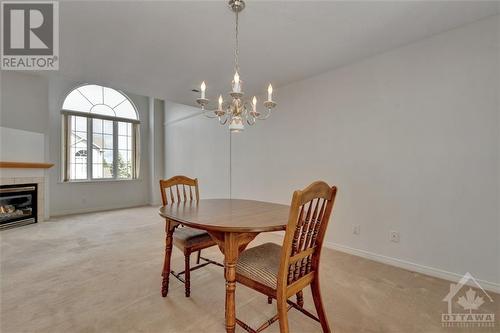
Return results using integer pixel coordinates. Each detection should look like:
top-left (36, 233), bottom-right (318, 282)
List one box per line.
top-left (61, 84), bottom-right (140, 181)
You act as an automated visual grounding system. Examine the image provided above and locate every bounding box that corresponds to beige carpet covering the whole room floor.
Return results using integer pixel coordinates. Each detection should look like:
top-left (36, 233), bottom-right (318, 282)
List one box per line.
top-left (0, 207), bottom-right (500, 333)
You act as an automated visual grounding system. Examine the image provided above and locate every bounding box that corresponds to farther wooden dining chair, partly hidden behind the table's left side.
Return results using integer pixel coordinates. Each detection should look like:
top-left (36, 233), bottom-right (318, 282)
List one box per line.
top-left (160, 176), bottom-right (224, 297)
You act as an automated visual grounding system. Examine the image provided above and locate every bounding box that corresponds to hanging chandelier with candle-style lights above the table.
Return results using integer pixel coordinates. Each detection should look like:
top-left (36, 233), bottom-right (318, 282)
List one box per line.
top-left (196, 0), bottom-right (276, 133)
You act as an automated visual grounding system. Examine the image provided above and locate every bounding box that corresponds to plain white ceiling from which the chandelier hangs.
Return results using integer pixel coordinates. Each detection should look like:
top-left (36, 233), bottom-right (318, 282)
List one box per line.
top-left (44, 0), bottom-right (500, 105)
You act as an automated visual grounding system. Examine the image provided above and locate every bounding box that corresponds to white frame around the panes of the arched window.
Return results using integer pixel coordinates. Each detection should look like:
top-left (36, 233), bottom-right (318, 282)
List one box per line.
top-left (61, 85), bottom-right (141, 183)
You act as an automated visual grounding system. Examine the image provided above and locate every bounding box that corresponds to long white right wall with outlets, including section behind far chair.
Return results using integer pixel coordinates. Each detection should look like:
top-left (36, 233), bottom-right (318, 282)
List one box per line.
top-left (165, 16), bottom-right (500, 290)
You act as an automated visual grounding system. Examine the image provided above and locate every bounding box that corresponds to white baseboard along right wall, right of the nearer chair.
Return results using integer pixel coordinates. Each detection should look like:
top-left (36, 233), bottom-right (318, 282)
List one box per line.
top-left (324, 241), bottom-right (500, 293)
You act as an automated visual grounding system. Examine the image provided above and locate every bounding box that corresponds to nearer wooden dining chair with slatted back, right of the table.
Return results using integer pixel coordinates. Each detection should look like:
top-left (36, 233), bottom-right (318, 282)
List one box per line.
top-left (236, 181), bottom-right (337, 333)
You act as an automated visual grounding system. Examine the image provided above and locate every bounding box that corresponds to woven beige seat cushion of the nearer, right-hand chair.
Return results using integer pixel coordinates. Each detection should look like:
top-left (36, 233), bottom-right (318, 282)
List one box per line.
top-left (236, 243), bottom-right (281, 289)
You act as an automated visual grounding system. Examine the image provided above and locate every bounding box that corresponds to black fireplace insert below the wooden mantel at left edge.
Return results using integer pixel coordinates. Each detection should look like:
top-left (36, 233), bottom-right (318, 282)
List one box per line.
top-left (0, 184), bottom-right (37, 229)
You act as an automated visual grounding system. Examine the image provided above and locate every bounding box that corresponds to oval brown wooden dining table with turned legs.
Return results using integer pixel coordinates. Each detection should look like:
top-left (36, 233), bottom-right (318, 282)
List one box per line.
top-left (159, 199), bottom-right (290, 333)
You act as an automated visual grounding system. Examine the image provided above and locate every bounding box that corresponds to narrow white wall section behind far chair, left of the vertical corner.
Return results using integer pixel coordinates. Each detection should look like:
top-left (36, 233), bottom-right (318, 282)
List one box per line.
top-left (164, 102), bottom-right (229, 198)
